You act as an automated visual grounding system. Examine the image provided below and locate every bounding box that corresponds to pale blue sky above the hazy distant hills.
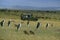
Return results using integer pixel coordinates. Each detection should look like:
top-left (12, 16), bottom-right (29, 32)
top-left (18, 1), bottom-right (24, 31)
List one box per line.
top-left (0, 0), bottom-right (60, 7)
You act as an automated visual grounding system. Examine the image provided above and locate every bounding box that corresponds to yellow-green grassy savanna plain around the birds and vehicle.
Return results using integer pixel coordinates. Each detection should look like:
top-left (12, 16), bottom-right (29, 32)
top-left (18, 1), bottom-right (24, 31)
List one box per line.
top-left (0, 10), bottom-right (60, 40)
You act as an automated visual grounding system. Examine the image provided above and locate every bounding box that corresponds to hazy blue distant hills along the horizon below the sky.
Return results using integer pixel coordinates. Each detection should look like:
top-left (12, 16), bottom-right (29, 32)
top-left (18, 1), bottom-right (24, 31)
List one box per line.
top-left (0, 6), bottom-right (60, 11)
